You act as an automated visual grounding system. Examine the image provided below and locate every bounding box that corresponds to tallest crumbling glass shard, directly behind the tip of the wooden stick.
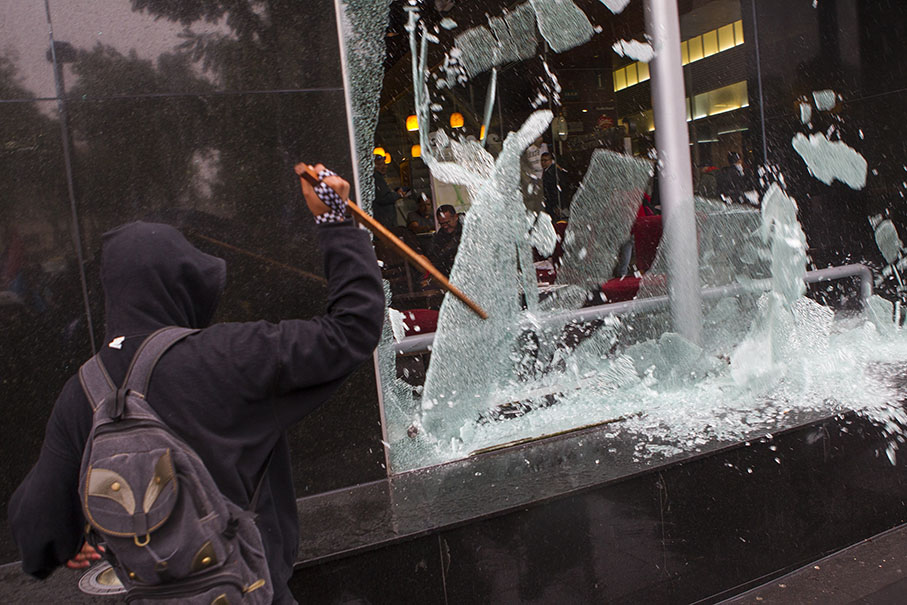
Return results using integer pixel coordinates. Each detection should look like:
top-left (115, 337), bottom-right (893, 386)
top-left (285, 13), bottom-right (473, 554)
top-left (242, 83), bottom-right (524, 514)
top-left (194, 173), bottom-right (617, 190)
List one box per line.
top-left (421, 111), bottom-right (552, 443)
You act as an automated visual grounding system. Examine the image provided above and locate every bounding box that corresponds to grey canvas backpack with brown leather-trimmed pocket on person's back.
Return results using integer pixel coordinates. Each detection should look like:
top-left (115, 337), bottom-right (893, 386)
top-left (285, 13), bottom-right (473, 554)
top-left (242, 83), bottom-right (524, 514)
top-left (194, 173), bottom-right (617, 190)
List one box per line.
top-left (79, 327), bottom-right (273, 605)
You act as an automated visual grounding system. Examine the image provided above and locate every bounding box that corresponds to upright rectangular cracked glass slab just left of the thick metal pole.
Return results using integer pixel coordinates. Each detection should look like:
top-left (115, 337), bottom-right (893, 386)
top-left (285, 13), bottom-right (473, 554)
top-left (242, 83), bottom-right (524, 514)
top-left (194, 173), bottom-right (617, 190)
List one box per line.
top-left (558, 149), bottom-right (652, 287)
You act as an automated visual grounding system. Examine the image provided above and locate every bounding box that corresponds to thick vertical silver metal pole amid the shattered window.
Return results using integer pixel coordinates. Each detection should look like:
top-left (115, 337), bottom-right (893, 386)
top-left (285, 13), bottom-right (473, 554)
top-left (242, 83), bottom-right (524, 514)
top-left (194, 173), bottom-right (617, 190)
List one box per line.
top-left (645, 0), bottom-right (702, 344)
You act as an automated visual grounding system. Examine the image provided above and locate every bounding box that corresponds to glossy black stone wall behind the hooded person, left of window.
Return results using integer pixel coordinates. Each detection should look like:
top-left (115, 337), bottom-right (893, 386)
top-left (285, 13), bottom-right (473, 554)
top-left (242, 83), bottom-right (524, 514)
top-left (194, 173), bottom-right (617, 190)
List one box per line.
top-left (0, 0), bottom-right (385, 562)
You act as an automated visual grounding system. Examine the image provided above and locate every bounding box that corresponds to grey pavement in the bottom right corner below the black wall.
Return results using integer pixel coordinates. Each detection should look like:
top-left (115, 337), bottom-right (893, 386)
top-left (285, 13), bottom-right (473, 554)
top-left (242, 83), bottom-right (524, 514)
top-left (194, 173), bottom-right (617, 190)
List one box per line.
top-left (721, 525), bottom-right (907, 605)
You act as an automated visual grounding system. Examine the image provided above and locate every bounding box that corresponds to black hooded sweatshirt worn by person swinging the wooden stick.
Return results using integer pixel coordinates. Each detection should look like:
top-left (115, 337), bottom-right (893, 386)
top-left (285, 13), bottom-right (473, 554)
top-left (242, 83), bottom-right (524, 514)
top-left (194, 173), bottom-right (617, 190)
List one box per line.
top-left (9, 221), bottom-right (384, 602)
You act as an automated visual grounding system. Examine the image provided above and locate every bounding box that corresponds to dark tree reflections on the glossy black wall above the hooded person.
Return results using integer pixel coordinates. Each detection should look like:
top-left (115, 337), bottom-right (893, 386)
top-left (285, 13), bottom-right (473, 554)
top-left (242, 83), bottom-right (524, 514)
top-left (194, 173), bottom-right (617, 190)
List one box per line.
top-left (63, 0), bottom-right (336, 242)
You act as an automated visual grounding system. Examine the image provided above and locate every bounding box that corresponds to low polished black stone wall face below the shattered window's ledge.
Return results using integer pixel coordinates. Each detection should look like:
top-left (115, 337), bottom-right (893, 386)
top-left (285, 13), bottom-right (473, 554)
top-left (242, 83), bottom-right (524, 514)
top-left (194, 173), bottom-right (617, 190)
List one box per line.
top-left (291, 417), bottom-right (907, 604)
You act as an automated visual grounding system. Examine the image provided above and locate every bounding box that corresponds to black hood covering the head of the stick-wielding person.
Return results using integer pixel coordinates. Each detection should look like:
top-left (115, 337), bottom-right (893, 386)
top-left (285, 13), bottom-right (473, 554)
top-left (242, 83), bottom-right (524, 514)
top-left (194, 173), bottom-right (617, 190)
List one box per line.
top-left (101, 222), bottom-right (227, 338)
